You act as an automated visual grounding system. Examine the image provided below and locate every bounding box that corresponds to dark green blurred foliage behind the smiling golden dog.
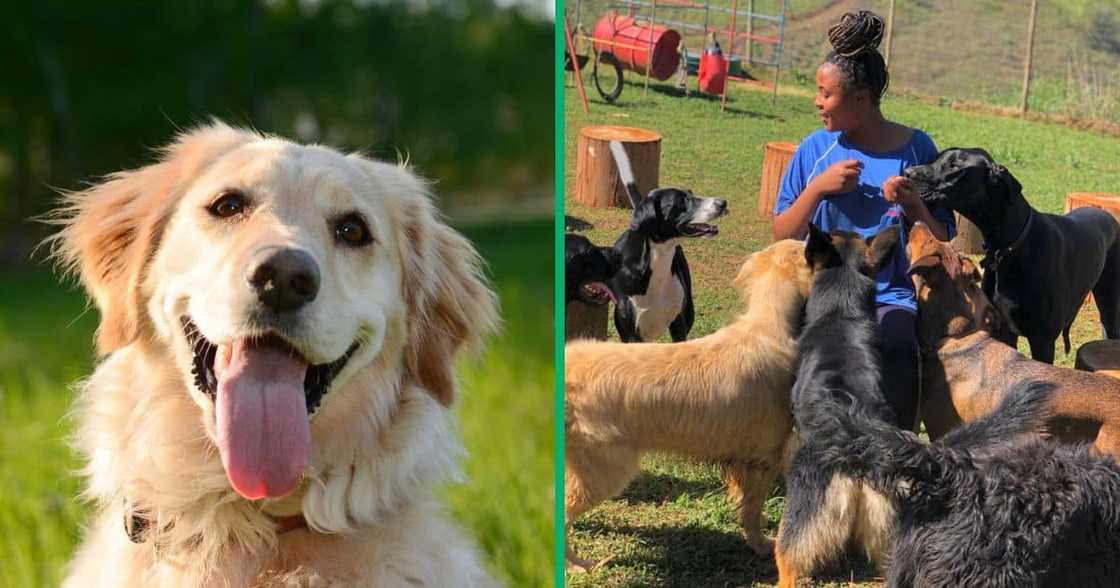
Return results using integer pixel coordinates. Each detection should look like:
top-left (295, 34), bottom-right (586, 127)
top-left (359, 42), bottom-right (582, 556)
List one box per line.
top-left (0, 0), bottom-right (553, 261)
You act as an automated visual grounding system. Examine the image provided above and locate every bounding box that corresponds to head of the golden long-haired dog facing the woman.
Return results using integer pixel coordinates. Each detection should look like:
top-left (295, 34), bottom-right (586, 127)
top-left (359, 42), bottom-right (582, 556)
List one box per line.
top-left (734, 239), bottom-right (813, 324)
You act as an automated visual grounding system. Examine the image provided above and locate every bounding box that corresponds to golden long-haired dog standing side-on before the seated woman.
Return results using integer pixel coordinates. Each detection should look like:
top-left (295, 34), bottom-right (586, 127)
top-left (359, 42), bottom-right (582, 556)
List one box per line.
top-left (564, 241), bottom-right (811, 564)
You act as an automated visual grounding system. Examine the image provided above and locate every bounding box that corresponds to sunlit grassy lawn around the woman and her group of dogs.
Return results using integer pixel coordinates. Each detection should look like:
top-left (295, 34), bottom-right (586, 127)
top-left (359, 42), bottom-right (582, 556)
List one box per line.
top-left (564, 74), bottom-right (1120, 586)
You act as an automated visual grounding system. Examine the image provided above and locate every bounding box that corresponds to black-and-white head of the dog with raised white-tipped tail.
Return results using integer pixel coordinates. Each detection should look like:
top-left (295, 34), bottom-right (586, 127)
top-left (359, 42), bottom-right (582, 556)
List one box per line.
top-left (629, 188), bottom-right (727, 243)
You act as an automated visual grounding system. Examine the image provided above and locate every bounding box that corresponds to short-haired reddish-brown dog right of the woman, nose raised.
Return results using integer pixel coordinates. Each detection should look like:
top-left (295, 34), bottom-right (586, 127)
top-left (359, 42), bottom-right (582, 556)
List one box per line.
top-left (907, 223), bottom-right (1120, 457)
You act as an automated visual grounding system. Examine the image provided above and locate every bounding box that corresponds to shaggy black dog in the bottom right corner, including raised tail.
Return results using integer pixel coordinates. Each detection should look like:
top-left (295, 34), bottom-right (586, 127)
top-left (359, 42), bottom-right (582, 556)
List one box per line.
top-left (810, 382), bottom-right (1120, 588)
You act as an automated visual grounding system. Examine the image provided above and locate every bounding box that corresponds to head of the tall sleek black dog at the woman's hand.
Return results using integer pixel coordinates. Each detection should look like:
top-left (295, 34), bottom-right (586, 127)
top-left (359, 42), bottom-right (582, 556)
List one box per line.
top-left (903, 148), bottom-right (1023, 224)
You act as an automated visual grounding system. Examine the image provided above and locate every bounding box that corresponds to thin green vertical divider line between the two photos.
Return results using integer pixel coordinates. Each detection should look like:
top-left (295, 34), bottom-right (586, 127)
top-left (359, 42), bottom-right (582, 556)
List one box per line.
top-left (552, 0), bottom-right (566, 588)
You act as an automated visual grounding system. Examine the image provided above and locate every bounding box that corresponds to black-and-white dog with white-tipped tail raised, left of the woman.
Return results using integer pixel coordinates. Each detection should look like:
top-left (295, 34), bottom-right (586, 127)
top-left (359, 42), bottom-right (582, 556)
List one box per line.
top-left (610, 141), bottom-right (727, 343)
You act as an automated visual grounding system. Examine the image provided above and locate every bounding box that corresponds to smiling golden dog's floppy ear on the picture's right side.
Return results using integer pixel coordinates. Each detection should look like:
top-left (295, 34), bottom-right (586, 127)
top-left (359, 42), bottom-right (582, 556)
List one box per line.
top-left (392, 169), bottom-right (498, 407)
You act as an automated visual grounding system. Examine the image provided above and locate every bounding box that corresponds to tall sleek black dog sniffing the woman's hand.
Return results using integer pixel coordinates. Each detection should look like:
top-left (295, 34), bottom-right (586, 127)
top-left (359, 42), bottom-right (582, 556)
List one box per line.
top-left (904, 149), bottom-right (1120, 363)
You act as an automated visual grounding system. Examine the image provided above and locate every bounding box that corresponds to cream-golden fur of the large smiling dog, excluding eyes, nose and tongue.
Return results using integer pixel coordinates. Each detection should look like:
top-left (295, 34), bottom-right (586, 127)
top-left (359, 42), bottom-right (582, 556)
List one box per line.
top-left (54, 121), bottom-right (497, 587)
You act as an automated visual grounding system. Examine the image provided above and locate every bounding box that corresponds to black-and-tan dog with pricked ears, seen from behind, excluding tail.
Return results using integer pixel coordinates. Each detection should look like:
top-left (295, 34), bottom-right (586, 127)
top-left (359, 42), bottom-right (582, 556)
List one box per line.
top-left (774, 224), bottom-right (899, 587)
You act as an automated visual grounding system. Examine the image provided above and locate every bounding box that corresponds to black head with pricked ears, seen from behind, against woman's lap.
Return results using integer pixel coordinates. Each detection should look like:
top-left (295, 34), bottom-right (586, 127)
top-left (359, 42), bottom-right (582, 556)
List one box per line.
top-left (805, 223), bottom-right (898, 279)
